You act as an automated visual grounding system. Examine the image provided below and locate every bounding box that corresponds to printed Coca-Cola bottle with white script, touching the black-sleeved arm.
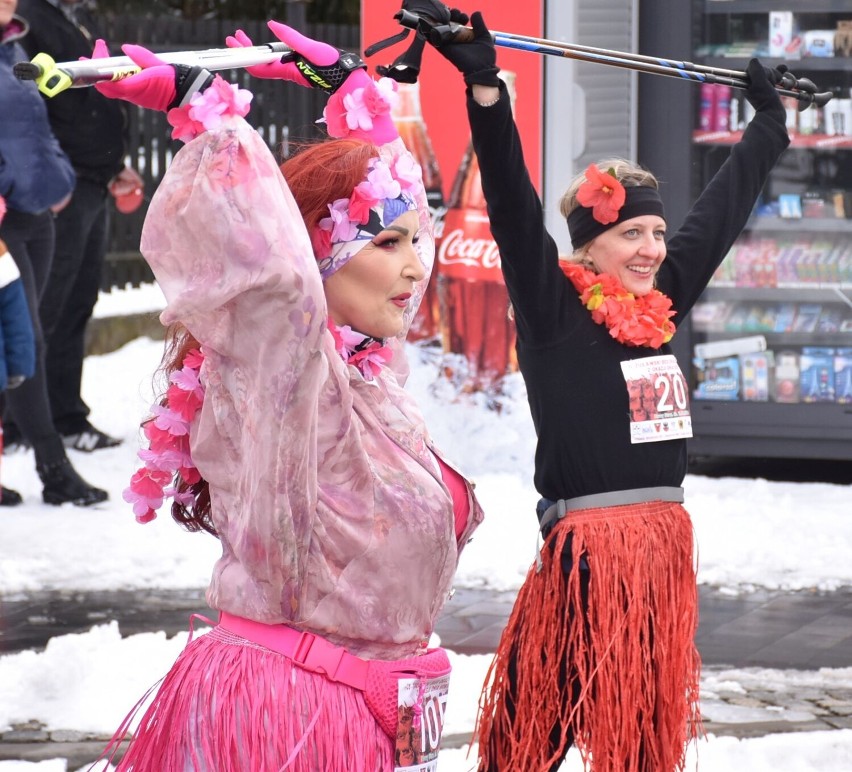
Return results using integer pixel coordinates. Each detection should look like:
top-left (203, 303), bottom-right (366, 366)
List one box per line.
top-left (437, 70), bottom-right (517, 389)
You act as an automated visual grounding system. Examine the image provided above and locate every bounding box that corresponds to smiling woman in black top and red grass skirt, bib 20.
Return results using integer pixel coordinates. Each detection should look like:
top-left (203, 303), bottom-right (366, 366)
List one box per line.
top-left (426, 7), bottom-right (789, 772)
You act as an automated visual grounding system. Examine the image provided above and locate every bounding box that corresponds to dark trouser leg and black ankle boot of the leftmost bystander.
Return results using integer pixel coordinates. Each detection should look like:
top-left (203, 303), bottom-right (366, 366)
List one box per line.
top-left (2, 211), bottom-right (107, 506)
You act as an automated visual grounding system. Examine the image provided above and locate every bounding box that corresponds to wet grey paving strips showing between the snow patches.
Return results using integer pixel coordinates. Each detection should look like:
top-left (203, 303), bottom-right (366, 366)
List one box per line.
top-left (0, 587), bottom-right (852, 770)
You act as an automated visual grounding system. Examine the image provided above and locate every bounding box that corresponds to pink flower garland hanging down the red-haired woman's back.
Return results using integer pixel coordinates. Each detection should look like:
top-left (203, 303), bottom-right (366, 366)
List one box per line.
top-left (122, 349), bottom-right (204, 523)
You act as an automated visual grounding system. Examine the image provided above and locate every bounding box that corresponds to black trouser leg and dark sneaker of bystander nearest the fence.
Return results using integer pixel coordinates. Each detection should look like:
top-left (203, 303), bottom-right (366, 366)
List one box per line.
top-left (40, 179), bottom-right (121, 452)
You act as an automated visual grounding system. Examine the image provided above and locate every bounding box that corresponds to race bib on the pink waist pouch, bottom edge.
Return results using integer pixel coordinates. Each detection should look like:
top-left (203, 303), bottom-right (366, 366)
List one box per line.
top-left (394, 675), bottom-right (450, 772)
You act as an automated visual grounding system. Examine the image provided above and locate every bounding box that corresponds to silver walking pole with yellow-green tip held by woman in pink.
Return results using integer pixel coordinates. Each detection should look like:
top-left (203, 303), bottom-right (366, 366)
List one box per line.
top-left (14, 42), bottom-right (292, 96)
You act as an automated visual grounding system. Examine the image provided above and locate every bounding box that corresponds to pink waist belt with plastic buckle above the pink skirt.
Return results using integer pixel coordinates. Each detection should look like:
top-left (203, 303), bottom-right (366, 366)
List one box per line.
top-left (219, 611), bottom-right (369, 691)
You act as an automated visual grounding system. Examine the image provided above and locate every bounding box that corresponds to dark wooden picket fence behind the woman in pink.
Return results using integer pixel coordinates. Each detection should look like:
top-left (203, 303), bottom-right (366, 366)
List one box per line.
top-left (101, 10), bottom-right (360, 292)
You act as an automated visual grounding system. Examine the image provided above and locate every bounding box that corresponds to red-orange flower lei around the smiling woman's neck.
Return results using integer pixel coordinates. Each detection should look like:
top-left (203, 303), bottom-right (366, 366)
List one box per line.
top-left (559, 260), bottom-right (677, 348)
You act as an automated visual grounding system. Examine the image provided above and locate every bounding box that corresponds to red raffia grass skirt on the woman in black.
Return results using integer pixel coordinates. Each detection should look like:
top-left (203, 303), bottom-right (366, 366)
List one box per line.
top-left (477, 501), bottom-right (703, 772)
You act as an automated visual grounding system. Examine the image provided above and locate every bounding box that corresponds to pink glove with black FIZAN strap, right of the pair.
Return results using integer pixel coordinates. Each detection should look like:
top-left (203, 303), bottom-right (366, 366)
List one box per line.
top-left (225, 21), bottom-right (366, 94)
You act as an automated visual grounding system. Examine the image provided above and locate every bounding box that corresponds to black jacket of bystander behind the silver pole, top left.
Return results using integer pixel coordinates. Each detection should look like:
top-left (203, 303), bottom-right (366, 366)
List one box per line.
top-left (18, 0), bottom-right (126, 185)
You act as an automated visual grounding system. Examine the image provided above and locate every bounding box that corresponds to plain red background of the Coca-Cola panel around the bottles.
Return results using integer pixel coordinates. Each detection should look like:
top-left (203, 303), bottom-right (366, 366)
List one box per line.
top-left (361, 0), bottom-right (544, 198)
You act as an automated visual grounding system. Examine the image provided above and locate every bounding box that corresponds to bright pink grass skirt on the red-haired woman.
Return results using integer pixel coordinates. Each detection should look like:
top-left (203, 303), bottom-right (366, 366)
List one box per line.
top-left (92, 627), bottom-right (393, 772)
